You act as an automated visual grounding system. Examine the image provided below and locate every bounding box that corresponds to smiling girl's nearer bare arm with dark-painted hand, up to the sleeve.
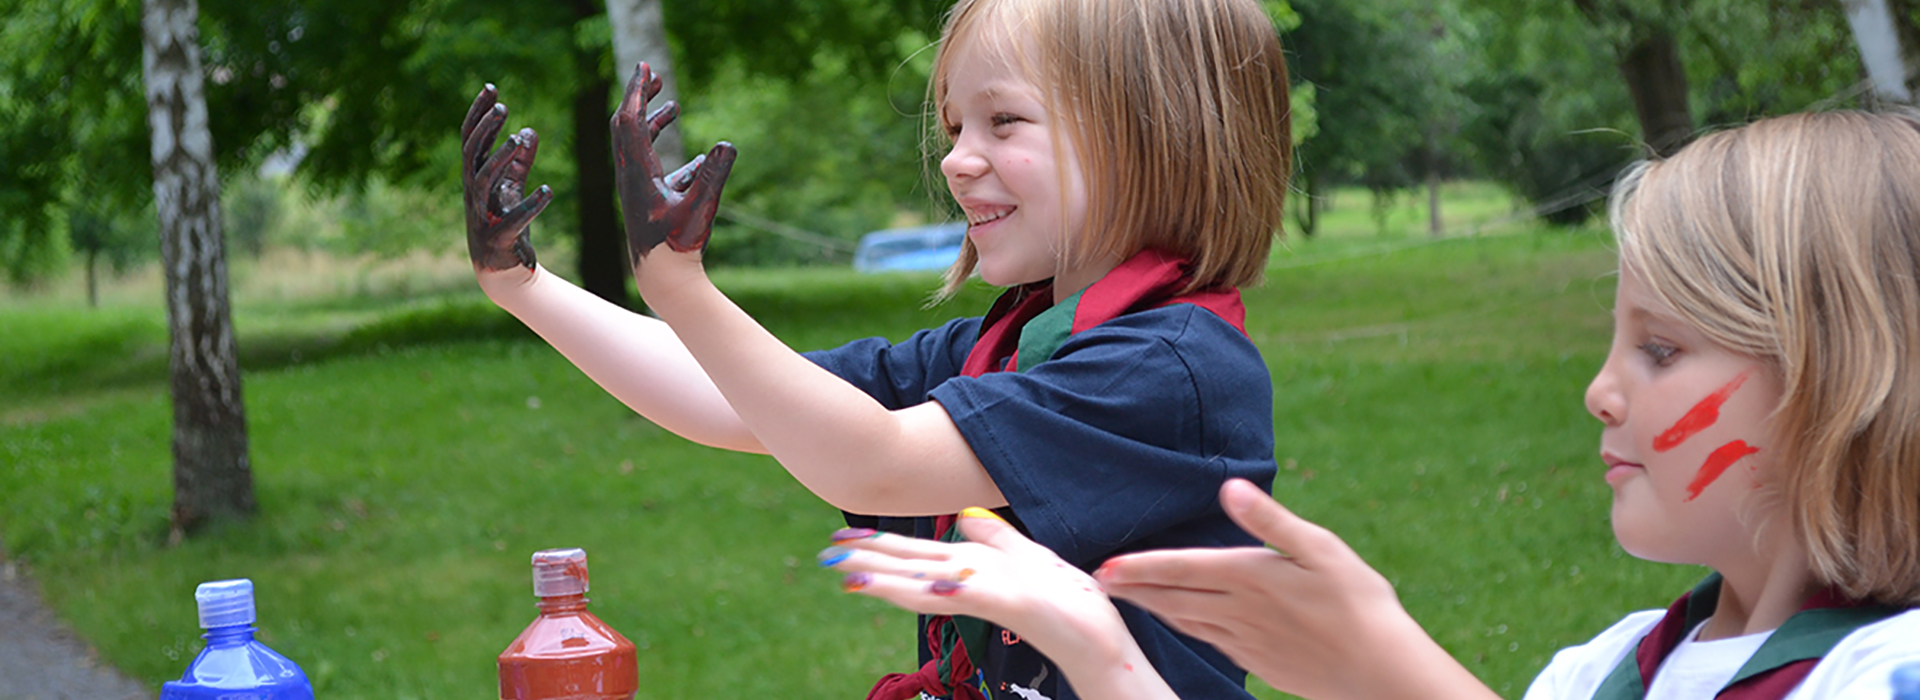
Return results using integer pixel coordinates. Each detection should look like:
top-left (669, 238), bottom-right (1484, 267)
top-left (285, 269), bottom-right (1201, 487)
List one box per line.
top-left (612, 63), bottom-right (1006, 516)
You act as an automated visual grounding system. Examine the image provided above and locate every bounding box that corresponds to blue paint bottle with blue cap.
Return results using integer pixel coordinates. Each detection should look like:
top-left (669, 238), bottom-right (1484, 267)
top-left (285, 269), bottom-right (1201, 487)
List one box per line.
top-left (159, 579), bottom-right (313, 700)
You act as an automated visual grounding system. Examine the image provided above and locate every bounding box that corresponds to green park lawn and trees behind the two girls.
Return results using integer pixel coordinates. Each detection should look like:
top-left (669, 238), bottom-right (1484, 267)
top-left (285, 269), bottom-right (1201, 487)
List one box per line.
top-left (0, 0), bottom-right (1920, 698)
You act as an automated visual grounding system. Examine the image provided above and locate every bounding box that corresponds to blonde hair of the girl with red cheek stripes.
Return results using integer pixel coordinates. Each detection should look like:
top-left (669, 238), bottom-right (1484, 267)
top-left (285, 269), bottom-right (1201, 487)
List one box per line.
top-left (1611, 113), bottom-right (1920, 604)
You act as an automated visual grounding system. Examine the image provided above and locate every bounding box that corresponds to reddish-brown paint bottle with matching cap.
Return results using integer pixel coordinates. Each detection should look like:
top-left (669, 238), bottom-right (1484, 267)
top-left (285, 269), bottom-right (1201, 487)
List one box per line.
top-left (499, 548), bottom-right (639, 700)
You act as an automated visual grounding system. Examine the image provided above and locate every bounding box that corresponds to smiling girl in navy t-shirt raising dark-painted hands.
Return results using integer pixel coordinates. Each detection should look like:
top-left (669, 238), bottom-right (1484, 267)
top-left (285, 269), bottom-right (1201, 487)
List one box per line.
top-left (463, 0), bottom-right (1290, 700)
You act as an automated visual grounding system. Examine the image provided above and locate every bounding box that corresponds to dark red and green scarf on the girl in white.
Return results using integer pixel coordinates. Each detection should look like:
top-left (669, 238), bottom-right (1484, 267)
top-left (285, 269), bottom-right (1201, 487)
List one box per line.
top-left (1594, 573), bottom-right (1903, 700)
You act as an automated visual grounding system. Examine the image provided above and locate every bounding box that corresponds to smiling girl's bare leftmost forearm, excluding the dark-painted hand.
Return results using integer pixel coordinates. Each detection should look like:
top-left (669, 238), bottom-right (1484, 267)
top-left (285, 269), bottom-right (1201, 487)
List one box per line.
top-left (480, 267), bottom-right (766, 453)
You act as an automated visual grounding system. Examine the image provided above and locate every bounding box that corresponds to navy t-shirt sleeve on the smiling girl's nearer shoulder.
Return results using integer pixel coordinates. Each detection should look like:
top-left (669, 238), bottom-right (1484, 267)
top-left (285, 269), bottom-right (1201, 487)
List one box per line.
top-left (931, 305), bottom-right (1273, 568)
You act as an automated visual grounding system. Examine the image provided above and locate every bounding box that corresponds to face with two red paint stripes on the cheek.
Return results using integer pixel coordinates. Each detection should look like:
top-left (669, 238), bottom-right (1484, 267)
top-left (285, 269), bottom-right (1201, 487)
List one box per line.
top-left (1586, 268), bottom-right (1782, 572)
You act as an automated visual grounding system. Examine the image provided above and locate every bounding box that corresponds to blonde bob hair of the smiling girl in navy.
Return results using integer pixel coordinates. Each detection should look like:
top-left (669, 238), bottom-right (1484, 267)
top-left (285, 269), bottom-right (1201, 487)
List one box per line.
top-left (927, 0), bottom-right (1292, 295)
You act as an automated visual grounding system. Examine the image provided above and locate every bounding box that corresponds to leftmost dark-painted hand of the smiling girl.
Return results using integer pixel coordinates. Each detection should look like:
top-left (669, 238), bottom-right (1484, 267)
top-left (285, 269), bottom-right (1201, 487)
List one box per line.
top-left (461, 84), bottom-right (553, 270)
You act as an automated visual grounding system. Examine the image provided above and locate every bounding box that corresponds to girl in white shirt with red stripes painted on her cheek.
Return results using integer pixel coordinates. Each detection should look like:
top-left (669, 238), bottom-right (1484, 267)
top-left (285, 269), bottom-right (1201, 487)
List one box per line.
top-left (833, 113), bottom-right (1920, 700)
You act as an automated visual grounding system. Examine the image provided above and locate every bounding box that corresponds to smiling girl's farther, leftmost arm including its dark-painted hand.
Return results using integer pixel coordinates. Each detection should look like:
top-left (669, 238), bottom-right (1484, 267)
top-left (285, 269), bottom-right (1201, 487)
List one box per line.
top-left (461, 84), bottom-right (764, 453)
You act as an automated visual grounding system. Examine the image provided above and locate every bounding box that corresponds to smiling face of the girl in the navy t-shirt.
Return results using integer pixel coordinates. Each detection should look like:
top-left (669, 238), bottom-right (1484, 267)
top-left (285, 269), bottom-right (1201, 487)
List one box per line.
top-left (939, 35), bottom-right (1106, 293)
